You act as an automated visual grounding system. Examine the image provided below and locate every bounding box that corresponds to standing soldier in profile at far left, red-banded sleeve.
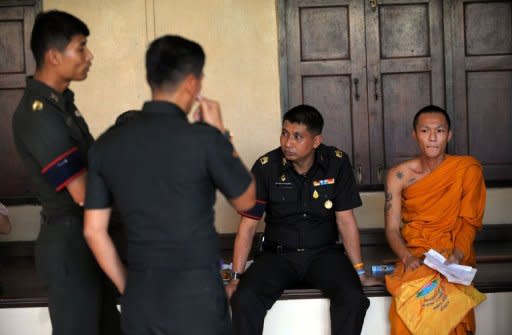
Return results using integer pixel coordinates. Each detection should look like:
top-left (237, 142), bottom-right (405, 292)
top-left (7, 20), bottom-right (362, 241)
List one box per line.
top-left (13, 11), bottom-right (120, 335)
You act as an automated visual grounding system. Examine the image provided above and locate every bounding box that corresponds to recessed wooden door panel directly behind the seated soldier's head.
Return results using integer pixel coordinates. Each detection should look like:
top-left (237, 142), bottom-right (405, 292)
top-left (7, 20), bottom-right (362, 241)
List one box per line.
top-left (302, 76), bottom-right (353, 157)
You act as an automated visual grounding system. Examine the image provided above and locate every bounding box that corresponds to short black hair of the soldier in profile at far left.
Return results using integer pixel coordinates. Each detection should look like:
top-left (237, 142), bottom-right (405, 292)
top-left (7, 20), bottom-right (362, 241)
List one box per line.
top-left (30, 10), bottom-right (89, 69)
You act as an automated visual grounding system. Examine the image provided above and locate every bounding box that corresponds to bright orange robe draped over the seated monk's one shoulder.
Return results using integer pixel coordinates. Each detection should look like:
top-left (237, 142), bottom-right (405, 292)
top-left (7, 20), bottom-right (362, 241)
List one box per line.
top-left (386, 155), bottom-right (486, 335)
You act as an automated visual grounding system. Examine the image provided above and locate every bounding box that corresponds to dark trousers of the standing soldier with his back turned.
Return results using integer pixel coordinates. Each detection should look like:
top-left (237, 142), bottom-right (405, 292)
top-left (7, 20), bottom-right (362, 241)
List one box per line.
top-left (121, 264), bottom-right (233, 335)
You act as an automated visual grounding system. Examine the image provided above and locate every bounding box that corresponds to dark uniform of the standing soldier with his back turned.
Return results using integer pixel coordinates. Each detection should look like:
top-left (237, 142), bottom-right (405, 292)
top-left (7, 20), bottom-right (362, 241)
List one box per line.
top-left (85, 101), bottom-right (251, 335)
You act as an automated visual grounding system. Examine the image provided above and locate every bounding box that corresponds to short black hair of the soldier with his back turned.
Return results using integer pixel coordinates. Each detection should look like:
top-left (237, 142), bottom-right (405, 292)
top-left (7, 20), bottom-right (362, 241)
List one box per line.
top-left (146, 35), bottom-right (205, 89)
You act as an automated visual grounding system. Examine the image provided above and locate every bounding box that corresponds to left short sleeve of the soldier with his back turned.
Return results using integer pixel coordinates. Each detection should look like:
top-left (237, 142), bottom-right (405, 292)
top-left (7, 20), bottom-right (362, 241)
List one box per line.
top-left (84, 146), bottom-right (112, 209)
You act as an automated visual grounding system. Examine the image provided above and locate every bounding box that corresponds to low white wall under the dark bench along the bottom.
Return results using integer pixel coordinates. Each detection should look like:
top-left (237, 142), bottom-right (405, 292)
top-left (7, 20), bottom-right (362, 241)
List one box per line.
top-left (0, 292), bottom-right (512, 335)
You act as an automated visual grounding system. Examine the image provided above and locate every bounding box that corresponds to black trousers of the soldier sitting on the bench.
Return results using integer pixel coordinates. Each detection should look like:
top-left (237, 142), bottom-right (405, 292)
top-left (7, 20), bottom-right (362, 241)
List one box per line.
top-left (231, 247), bottom-right (370, 335)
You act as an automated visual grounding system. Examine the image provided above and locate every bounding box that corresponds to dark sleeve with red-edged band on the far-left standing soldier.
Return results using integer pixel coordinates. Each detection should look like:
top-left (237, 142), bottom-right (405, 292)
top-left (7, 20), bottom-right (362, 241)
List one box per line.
top-left (18, 110), bottom-right (86, 192)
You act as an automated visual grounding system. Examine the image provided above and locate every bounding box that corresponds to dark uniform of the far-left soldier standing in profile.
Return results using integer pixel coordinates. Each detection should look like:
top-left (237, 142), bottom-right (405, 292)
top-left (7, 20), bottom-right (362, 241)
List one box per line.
top-left (13, 78), bottom-right (120, 335)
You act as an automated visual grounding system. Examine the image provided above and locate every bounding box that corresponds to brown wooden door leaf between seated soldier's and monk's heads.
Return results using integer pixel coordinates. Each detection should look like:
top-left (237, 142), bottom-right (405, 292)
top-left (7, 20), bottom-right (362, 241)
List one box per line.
top-left (365, 0), bottom-right (445, 184)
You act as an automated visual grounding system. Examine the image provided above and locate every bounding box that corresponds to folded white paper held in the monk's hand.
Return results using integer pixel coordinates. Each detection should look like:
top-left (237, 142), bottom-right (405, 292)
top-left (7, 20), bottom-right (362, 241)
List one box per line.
top-left (423, 249), bottom-right (476, 286)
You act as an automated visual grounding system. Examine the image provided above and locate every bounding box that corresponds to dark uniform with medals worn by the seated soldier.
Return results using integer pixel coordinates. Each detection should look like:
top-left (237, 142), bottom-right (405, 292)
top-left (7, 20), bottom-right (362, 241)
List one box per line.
top-left (231, 144), bottom-right (369, 335)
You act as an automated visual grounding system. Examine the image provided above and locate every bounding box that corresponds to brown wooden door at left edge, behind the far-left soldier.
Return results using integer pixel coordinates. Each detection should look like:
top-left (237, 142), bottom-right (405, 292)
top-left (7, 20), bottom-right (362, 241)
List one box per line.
top-left (0, 1), bottom-right (39, 198)
